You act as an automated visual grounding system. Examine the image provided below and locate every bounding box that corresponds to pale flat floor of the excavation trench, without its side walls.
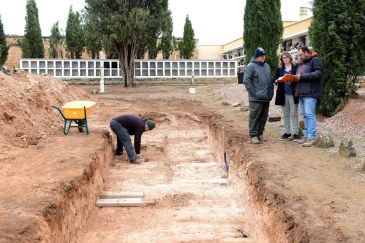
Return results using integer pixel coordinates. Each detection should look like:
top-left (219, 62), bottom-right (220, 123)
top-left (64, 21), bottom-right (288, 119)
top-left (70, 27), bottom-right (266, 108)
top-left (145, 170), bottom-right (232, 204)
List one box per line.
top-left (78, 115), bottom-right (262, 242)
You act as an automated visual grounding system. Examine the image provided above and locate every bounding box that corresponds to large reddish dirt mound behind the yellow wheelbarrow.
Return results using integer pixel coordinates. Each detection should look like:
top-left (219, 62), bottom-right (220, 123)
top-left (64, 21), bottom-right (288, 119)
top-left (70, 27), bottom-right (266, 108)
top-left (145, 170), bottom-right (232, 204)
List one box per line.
top-left (0, 72), bottom-right (87, 147)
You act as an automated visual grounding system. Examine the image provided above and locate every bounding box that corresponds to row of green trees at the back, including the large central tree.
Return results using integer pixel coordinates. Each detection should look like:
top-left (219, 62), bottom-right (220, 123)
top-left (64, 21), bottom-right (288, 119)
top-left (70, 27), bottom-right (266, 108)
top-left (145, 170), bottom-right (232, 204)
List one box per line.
top-left (0, 0), bottom-right (195, 86)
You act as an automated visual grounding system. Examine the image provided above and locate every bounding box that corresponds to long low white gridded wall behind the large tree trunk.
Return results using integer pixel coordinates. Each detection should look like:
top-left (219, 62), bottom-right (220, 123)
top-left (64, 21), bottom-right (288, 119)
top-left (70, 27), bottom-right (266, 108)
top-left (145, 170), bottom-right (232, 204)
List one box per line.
top-left (20, 59), bottom-right (237, 79)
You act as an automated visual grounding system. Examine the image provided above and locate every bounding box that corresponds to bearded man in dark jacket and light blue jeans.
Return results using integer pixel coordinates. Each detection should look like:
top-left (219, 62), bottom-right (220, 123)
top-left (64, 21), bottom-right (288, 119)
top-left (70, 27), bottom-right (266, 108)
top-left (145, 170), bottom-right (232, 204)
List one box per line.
top-left (297, 46), bottom-right (323, 147)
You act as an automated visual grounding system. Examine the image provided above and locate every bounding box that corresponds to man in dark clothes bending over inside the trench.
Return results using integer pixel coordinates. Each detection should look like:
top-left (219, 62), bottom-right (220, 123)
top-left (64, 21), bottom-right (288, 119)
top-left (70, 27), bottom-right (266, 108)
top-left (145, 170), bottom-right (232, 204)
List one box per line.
top-left (110, 115), bottom-right (156, 164)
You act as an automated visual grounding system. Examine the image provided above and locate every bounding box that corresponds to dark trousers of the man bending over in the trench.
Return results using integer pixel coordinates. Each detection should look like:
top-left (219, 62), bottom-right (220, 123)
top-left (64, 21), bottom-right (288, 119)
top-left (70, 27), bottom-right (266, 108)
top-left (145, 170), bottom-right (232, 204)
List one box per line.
top-left (110, 120), bottom-right (137, 161)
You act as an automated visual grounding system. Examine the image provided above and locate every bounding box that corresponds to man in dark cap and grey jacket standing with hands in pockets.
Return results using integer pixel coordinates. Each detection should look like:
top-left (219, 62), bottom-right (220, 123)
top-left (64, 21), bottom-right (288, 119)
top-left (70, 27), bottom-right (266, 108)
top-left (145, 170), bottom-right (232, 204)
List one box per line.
top-left (243, 47), bottom-right (274, 144)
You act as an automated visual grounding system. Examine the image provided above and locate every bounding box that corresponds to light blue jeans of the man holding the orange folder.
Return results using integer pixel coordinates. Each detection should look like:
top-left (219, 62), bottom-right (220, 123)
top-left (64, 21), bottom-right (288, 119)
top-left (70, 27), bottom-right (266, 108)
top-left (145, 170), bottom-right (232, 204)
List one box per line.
top-left (299, 97), bottom-right (317, 140)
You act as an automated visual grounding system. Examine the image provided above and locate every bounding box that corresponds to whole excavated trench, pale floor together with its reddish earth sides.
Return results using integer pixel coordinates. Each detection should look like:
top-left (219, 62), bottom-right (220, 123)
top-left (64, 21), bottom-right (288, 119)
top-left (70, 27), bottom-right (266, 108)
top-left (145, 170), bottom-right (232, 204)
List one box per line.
top-left (39, 113), bottom-right (302, 242)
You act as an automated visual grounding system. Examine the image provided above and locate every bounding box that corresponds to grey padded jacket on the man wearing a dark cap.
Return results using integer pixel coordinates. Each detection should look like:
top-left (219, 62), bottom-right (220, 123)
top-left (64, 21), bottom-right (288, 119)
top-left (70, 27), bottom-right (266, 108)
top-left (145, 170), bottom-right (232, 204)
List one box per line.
top-left (243, 58), bottom-right (274, 102)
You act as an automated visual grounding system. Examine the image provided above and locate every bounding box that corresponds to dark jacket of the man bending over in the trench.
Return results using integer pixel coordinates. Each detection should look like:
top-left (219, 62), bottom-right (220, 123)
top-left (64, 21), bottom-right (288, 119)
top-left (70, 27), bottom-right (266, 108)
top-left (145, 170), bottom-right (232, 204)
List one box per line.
top-left (113, 115), bottom-right (146, 154)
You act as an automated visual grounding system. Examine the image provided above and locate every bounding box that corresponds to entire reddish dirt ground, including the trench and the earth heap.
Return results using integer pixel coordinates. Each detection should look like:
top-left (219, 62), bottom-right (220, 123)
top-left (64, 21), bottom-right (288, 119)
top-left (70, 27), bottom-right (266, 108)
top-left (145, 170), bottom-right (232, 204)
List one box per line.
top-left (0, 73), bottom-right (365, 242)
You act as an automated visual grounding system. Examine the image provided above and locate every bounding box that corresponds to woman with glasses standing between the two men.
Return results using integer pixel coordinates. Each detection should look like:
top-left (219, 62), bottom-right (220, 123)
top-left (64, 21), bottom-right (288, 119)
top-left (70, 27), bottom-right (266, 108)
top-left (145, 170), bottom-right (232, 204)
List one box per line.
top-left (274, 51), bottom-right (300, 140)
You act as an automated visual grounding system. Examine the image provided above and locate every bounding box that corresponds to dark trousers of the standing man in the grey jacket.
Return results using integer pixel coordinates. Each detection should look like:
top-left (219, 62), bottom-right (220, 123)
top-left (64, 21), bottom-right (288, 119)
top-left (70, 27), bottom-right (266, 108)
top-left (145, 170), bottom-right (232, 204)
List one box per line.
top-left (248, 101), bottom-right (270, 138)
